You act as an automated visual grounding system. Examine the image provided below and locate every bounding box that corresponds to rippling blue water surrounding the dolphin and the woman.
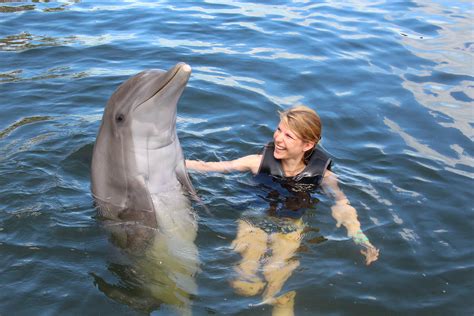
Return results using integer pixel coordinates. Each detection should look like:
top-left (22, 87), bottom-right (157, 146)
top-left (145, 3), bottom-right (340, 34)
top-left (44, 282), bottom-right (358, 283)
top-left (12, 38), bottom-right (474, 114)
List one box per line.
top-left (0, 0), bottom-right (474, 315)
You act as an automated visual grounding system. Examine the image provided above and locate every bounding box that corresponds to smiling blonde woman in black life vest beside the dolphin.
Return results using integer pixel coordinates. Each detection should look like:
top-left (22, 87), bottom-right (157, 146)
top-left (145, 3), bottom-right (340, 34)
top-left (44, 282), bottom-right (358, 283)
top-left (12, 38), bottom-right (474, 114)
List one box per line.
top-left (186, 106), bottom-right (379, 312)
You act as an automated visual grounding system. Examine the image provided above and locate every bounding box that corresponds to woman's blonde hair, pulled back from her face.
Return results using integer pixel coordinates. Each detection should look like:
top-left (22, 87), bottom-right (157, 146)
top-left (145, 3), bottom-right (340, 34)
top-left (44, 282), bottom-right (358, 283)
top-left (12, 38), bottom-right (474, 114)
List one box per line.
top-left (279, 105), bottom-right (323, 144)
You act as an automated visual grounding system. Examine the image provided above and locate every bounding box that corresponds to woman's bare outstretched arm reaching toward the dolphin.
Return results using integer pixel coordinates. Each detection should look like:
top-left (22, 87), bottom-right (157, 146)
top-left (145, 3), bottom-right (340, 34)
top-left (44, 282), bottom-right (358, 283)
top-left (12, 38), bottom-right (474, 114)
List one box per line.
top-left (186, 155), bottom-right (262, 174)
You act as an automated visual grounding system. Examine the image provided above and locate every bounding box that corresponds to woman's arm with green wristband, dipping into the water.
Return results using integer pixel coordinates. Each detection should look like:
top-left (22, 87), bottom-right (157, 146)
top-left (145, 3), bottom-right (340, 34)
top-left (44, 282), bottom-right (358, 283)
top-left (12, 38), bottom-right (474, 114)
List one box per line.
top-left (322, 170), bottom-right (379, 265)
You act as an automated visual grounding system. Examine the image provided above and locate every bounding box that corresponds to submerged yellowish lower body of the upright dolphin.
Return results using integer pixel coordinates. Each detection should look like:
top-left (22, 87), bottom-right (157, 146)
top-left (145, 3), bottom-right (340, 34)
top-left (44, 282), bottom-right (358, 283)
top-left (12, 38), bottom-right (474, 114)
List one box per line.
top-left (92, 192), bottom-right (199, 315)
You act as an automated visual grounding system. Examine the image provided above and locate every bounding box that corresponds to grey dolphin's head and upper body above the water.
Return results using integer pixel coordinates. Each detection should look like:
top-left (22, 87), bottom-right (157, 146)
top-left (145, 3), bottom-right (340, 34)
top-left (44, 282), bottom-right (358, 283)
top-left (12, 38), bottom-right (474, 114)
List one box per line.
top-left (91, 63), bottom-right (191, 221)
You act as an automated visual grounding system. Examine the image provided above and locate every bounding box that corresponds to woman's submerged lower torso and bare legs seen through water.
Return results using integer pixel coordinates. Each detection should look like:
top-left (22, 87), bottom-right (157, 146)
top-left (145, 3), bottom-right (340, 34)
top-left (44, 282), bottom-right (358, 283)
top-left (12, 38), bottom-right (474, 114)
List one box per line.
top-left (230, 176), bottom-right (318, 315)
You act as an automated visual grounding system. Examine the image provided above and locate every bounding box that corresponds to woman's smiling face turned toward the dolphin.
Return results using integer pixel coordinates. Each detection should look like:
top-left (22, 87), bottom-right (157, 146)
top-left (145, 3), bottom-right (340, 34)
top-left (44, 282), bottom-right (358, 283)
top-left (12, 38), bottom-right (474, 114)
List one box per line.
top-left (273, 121), bottom-right (314, 159)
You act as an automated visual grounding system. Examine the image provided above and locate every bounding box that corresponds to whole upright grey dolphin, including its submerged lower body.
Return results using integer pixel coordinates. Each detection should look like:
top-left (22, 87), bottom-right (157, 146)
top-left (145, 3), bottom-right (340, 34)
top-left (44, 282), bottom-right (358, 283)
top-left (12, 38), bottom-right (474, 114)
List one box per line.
top-left (91, 63), bottom-right (199, 314)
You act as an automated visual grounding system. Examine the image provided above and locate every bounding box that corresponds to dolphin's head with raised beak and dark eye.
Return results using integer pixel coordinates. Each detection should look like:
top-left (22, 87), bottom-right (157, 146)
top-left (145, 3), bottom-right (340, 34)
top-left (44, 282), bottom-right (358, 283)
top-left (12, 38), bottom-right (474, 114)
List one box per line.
top-left (103, 63), bottom-right (191, 148)
